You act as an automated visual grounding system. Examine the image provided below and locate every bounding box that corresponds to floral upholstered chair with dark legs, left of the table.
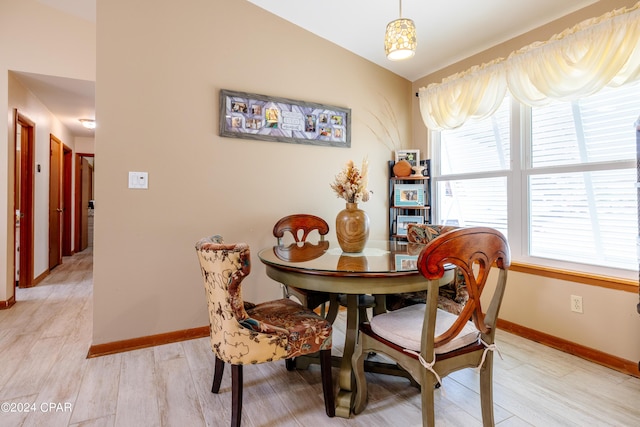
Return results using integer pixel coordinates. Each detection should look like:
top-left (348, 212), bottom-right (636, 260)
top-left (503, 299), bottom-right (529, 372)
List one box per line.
top-left (196, 236), bottom-right (335, 426)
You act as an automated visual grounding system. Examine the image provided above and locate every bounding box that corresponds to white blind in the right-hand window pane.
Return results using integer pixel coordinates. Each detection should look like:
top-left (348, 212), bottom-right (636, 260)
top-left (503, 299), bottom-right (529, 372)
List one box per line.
top-left (528, 84), bottom-right (640, 269)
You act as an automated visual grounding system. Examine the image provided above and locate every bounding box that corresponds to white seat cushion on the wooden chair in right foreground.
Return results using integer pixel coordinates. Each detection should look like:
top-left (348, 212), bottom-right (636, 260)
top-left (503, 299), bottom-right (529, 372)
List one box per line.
top-left (370, 304), bottom-right (480, 354)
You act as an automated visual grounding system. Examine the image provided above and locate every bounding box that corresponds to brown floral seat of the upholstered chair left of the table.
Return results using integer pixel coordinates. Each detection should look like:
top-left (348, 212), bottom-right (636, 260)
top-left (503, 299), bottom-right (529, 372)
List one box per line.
top-left (243, 298), bottom-right (332, 358)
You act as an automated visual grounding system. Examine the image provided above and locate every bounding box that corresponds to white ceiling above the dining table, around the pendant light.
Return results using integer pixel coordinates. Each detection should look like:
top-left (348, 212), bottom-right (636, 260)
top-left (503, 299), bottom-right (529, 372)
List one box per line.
top-left (248, 0), bottom-right (606, 82)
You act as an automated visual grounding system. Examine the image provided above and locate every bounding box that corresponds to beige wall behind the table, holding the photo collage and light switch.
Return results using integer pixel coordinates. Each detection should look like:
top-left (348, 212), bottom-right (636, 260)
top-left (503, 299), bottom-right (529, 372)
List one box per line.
top-left (94, 0), bottom-right (411, 344)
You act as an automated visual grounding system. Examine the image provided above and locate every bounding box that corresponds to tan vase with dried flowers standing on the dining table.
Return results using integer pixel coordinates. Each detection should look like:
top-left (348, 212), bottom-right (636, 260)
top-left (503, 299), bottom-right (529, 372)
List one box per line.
top-left (331, 159), bottom-right (371, 253)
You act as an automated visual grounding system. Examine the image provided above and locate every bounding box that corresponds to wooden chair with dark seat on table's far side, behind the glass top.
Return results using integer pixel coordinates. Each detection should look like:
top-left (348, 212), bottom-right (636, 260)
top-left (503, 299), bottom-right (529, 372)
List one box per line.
top-left (273, 214), bottom-right (339, 322)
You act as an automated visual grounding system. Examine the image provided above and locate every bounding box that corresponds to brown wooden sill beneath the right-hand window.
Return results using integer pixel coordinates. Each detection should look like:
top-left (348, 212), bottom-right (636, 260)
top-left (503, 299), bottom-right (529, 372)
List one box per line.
top-left (509, 262), bottom-right (638, 293)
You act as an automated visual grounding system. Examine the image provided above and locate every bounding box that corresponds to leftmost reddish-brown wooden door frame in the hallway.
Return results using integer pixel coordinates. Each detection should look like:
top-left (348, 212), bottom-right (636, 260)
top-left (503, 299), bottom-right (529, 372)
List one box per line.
top-left (12, 108), bottom-right (36, 288)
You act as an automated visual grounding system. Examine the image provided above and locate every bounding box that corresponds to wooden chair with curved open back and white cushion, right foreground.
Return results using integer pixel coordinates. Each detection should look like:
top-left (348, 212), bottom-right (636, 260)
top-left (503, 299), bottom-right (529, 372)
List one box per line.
top-left (352, 227), bottom-right (510, 426)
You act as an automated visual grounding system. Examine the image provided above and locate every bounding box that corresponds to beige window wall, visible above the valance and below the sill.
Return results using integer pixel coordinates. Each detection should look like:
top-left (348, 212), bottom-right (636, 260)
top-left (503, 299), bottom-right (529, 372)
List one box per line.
top-left (411, 0), bottom-right (640, 361)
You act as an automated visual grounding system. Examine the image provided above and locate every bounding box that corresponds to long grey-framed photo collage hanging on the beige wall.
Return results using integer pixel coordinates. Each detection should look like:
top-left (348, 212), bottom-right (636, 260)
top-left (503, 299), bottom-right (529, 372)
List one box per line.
top-left (219, 89), bottom-right (351, 148)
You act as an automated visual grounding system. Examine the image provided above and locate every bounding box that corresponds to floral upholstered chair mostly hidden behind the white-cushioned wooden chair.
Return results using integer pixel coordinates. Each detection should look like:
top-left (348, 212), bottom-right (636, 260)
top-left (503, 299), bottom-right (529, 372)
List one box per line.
top-left (387, 224), bottom-right (469, 314)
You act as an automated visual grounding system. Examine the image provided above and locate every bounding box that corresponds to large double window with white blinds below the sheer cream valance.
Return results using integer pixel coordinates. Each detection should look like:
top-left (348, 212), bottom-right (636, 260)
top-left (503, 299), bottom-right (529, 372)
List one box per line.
top-left (433, 84), bottom-right (640, 277)
